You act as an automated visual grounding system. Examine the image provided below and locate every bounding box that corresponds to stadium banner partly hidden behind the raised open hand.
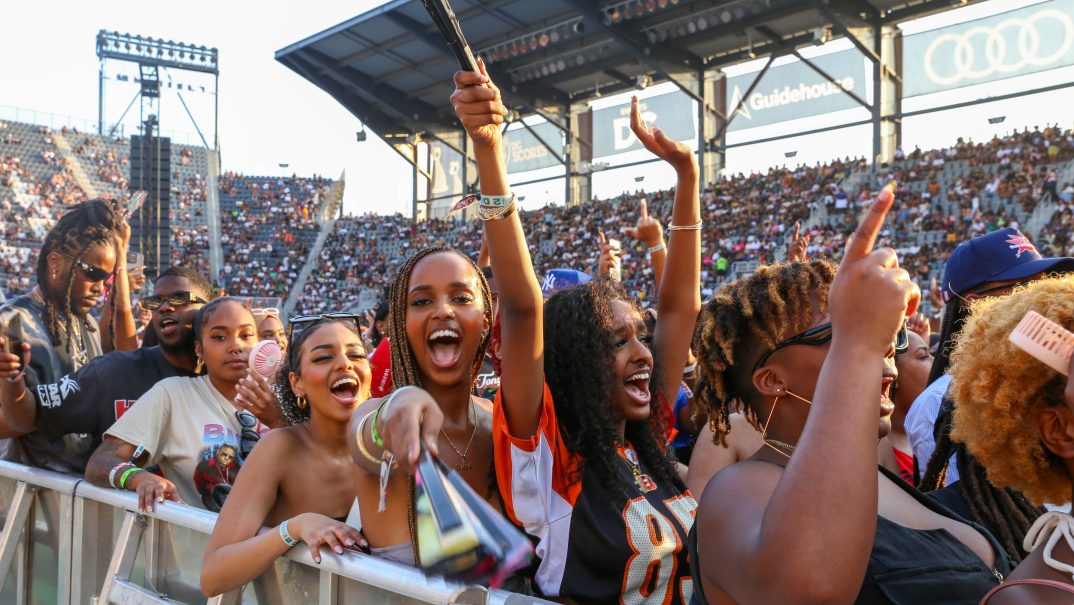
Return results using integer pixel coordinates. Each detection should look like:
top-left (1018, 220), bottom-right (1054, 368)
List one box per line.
top-left (593, 91), bottom-right (697, 158)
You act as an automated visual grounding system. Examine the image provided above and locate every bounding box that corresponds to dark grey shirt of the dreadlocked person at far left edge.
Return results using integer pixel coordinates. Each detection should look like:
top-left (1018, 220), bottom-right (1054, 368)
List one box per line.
top-left (0, 293), bottom-right (101, 475)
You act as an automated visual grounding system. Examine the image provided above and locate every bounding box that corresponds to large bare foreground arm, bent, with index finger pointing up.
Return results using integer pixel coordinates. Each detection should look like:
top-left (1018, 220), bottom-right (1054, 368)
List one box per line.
top-left (698, 186), bottom-right (919, 605)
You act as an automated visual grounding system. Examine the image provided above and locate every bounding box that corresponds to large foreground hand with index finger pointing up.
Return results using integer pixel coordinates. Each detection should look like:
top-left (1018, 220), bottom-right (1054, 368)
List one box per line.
top-left (828, 186), bottom-right (921, 355)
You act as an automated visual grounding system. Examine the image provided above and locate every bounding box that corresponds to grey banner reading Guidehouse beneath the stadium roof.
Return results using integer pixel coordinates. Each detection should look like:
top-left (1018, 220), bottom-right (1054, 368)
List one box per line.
top-left (727, 48), bottom-right (868, 132)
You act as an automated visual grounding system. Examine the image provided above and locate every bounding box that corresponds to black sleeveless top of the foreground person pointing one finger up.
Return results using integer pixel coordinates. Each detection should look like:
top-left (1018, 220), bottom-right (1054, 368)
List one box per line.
top-left (687, 466), bottom-right (1012, 605)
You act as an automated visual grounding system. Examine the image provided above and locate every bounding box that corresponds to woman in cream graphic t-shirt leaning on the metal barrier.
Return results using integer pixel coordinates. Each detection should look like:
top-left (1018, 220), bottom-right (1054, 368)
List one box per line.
top-left (86, 297), bottom-right (269, 510)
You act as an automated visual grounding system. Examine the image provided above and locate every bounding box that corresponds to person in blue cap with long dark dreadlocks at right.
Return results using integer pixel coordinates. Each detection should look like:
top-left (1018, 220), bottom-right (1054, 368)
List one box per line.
top-left (905, 228), bottom-right (1074, 562)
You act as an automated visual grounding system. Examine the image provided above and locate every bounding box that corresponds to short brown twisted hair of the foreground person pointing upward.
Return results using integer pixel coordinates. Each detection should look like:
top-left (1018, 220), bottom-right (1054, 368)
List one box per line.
top-left (694, 259), bottom-right (836, 447)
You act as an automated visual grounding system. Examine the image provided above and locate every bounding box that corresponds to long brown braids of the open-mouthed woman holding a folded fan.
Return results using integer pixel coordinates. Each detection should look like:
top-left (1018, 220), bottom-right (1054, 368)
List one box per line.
top-left (388, 246), bottom-right (492, 566)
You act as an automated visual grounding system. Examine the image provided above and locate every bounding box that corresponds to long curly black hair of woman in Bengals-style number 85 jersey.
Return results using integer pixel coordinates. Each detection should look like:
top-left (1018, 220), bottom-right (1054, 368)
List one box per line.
top-left (545, 277), bottom-right (686, 504)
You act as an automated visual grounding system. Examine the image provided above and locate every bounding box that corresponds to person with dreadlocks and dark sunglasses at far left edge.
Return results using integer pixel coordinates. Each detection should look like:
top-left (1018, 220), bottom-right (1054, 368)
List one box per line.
top-left (0, 200), bottom-right (130, 474)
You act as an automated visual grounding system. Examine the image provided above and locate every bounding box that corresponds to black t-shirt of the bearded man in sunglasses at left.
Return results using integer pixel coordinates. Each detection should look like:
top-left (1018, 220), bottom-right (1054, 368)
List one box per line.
top-left (33, 347), bottom-right (194, 447)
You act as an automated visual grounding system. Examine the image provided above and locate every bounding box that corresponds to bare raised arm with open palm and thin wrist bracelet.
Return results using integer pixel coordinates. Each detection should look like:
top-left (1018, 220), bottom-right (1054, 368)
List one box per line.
top-left (630, 97), bottom-right (701, 405)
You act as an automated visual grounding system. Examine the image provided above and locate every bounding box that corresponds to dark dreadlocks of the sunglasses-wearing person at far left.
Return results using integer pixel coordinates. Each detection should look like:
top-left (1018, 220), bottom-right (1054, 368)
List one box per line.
top-left (37, 200), bottom-right (124, 354)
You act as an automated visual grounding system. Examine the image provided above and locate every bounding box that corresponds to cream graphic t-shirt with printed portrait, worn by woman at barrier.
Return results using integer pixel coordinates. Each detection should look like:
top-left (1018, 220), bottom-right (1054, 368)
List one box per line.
top-left (105, 376), bottom-right (269, 510)
